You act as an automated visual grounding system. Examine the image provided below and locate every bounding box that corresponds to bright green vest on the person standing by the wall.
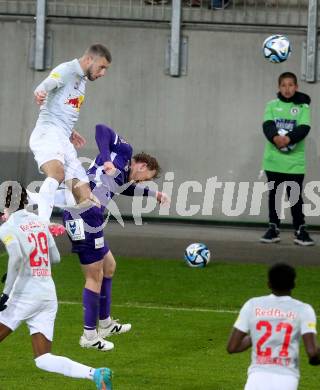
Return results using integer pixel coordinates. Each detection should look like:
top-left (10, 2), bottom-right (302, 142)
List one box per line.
top-left (262, 99), bottom-right (310, 174)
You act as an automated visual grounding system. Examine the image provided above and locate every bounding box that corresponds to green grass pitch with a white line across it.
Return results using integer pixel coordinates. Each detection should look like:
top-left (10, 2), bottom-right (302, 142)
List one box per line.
top-left (0, 254), bottom-right (320, 390)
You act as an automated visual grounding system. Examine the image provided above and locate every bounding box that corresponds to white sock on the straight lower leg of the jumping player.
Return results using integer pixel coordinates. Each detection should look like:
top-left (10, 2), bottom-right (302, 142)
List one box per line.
top-left (38, 177), bottom-right (59, 221)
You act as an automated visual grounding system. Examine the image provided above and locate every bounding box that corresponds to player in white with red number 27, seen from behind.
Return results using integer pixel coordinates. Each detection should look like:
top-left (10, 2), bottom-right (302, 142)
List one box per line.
top-left (227, 263), bottom-right (320, 390)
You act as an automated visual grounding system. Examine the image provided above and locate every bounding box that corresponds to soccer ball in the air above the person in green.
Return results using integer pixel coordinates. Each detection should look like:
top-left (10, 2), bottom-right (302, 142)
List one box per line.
top-left (262, 35), bottom-right (291, 63)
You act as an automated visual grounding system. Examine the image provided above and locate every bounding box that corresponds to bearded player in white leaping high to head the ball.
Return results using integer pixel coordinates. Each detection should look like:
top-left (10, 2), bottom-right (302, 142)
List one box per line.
top-left (29, 44), bottom-right (112, 233)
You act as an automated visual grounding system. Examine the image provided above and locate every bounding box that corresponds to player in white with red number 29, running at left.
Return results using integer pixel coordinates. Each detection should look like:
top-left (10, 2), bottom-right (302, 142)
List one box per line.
top-left (0, 183), bottom-right (111, 390)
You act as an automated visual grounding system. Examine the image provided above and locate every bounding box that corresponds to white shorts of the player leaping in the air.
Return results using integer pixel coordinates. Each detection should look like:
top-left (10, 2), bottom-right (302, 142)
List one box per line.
top-left (29, 124), bottom-right (88, 183)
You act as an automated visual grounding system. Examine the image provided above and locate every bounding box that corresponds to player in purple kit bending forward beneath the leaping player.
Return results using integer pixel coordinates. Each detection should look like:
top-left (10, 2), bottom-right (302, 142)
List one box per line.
top-left (63, 124), bottom-right (169, 351)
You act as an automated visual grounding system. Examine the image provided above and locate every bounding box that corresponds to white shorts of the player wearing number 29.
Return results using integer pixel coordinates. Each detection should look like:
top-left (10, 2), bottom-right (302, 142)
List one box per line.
top-left (0, 297), bottom-right (58, 341)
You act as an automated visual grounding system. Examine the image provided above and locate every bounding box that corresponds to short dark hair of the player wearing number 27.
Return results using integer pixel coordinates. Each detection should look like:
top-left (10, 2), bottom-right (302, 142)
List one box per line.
top-left (268, 263), bottom-right (296, 292)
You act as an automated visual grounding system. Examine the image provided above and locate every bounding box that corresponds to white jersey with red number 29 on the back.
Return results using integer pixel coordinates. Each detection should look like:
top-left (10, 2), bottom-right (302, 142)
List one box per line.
top-left (0, 210), bottom-right (57, 302)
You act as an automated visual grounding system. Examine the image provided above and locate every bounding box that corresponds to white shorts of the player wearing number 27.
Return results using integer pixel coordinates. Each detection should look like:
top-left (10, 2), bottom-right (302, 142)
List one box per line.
top-left (244, 372), bottom-right (299, 390)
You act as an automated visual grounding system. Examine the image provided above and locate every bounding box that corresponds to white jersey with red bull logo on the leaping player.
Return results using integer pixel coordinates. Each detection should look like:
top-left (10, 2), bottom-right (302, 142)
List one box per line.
top-left (36, 59), bottom-right (87, 137)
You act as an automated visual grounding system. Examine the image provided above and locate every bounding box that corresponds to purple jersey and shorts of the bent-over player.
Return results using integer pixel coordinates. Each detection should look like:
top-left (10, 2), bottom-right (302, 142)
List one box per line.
top-left (63, 124), bottom-right (155, 264)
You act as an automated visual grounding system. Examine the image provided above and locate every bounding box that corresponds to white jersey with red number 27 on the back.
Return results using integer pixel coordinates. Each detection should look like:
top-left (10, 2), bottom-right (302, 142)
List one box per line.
top-left (234, 294), bottom-right (316, 377)
